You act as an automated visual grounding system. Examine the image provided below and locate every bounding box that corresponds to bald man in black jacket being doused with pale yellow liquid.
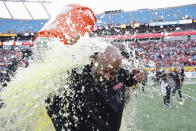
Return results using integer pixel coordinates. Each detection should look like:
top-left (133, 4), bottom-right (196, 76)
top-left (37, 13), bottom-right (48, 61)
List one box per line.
top-left (46, 46), bottom-right (145, 131)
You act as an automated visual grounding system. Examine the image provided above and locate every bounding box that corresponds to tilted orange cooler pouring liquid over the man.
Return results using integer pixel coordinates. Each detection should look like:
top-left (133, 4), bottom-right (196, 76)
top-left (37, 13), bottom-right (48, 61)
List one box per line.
top-left (34, 4), bottom-right (97, 45)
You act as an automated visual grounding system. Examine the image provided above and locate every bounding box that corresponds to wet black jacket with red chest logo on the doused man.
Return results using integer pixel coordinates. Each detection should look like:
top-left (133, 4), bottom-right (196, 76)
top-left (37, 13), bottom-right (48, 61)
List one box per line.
top-left (46, 66), bottom-right (134, 131)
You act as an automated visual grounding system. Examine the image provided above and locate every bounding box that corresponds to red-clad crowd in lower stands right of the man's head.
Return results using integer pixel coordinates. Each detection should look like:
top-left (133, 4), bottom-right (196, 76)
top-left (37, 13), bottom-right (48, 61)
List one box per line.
top-left (137, 40), bottom-right (196, 67)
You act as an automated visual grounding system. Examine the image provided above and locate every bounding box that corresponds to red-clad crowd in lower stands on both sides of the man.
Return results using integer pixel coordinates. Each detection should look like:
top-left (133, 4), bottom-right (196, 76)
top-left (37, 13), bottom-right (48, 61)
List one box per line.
top-left (0, 40), bottom-right (196, 75)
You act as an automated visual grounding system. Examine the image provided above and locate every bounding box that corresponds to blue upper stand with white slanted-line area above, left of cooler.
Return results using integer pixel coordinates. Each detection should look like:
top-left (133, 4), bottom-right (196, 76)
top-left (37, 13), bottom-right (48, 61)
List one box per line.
top-left (0, 0), bottom-right (50, 34)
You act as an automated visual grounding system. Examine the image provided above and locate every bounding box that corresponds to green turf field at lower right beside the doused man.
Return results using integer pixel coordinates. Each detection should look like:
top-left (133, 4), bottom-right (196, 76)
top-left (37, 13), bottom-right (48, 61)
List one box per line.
top-left (123, 79), bottom-right (196, 131)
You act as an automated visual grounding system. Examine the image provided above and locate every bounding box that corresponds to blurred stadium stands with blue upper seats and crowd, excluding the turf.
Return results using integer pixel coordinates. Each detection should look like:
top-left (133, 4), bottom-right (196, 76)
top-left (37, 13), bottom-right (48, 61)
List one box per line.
top-left (0, 0), bottom-right (196, 77)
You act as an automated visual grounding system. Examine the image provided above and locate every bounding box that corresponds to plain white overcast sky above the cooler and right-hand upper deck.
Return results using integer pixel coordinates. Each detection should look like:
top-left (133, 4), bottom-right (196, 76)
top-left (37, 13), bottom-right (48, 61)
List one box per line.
top-left (51, 0), bottom-right (196, 14)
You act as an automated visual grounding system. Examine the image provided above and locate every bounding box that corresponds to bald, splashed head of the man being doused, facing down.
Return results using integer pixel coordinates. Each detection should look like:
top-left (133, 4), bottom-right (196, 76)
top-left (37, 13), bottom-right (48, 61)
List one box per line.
top-left (92, 46), bottom-right (121, 83)
